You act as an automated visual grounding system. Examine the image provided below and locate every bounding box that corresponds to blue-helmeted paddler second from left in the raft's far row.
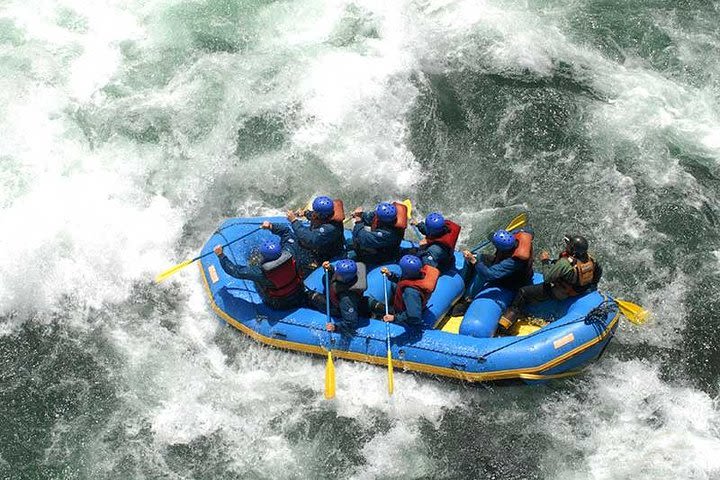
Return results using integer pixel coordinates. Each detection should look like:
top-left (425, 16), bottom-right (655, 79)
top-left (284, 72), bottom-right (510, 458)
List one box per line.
top-left (352, 202), bottom-right (408, 265)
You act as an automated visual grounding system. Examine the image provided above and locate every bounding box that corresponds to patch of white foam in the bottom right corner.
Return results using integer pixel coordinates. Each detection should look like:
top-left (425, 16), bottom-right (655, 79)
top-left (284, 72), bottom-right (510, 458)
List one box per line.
top-left (544, 360), bottom-right (720, 479)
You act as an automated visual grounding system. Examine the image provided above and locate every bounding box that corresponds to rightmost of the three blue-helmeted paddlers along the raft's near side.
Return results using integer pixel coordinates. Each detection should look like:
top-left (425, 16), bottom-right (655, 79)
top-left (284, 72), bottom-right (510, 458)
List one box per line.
top-left (381, 255), bottom-right (440, 328)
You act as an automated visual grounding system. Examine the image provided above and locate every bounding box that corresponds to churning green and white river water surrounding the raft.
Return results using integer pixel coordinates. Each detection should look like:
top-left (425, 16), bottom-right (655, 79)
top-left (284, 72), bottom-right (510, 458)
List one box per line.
top-left (0, 0), bottom-right (720, 479)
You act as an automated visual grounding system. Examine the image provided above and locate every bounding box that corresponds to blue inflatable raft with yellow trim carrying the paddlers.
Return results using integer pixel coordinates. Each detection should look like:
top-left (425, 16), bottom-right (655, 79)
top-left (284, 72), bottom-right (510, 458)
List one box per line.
top-left (200, 217), bottom-right (619, 382)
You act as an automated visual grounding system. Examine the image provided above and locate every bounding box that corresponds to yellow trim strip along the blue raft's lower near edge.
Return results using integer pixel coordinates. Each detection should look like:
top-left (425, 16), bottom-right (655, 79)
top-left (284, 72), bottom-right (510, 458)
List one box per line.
top-left (198, 262), bottom-right (620, 382)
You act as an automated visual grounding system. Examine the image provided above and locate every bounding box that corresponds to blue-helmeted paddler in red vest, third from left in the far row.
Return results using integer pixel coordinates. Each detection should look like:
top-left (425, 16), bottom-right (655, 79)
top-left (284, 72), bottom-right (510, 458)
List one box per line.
top-left (416, 212), bottom-right (461, 273)
